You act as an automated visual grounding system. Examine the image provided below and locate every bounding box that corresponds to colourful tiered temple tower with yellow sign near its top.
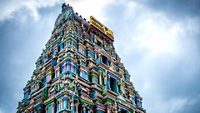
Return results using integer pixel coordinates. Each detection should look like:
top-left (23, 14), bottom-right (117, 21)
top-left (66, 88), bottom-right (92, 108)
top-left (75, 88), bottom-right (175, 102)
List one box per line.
top-left (17, 4), bottom-right (146, 113)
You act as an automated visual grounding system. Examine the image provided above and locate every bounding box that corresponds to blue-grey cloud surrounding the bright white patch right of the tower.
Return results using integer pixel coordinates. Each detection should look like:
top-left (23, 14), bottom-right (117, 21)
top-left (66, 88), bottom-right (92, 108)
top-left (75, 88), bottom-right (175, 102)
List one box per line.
top-left (104, 0), bottom-right (200, 113)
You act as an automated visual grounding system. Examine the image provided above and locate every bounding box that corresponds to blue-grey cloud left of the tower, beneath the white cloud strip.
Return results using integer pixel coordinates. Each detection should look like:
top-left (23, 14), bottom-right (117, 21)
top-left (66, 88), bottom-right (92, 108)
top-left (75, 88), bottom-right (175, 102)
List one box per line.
top-left (0, 6), bottom-right (59, 113)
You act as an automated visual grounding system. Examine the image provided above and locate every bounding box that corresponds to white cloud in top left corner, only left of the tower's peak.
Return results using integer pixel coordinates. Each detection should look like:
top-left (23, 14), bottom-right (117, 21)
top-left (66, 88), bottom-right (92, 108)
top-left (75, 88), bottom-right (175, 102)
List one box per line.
top-left (0, 0), bottom-right (60, 21)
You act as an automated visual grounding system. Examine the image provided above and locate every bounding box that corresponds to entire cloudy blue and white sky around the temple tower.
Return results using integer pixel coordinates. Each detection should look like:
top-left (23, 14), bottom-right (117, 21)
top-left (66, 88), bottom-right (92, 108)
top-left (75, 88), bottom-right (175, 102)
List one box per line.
top-left (0, 0), bottom-right (200, 113)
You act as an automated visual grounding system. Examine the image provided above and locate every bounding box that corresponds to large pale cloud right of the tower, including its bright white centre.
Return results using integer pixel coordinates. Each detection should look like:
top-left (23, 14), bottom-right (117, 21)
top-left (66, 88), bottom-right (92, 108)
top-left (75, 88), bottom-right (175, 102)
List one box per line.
top-left (104, 1), bottom-right (200, 113)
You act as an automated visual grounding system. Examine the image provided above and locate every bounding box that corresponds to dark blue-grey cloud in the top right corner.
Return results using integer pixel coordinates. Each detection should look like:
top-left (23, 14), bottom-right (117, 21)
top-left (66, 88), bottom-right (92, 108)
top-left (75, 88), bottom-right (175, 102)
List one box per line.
top-left (138, 0), bottom-right (200, 19)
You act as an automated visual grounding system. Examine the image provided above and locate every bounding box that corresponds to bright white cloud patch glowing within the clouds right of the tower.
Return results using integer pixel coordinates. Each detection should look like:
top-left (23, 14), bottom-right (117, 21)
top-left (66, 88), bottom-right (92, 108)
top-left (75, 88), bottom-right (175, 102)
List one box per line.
top-left (115, 3), bottom-right (185, 55)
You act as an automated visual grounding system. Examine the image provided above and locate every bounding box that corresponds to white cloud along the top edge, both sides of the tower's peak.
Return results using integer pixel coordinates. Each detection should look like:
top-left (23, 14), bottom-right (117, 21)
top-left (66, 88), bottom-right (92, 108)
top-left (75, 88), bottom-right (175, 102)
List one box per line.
top-left (0, 0), bottom-right (114, 21)
